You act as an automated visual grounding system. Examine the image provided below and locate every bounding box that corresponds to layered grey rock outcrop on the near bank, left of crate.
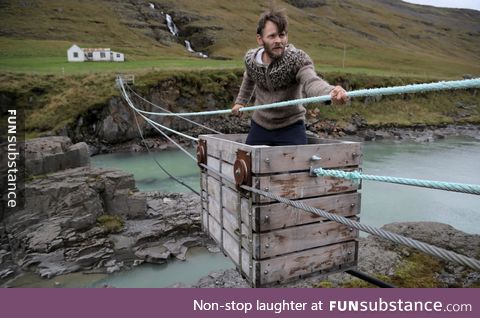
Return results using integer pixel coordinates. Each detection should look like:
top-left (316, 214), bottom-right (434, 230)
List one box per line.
top-left (0, 137), bottom-right (209, 285)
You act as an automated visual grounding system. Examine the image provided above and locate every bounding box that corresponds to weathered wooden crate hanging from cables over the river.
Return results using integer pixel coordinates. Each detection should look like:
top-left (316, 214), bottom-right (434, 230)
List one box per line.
top-left (197, 134), bottom-right (362, 287)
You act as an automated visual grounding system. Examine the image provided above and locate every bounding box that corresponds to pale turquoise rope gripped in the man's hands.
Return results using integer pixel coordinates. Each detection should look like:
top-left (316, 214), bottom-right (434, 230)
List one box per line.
top-left (127, 78), bottom-right (480, 116)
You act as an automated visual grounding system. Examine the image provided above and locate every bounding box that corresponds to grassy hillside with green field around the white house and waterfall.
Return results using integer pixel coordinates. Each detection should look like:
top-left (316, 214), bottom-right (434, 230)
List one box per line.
top-left (0, 0), bottom-right (480, 78)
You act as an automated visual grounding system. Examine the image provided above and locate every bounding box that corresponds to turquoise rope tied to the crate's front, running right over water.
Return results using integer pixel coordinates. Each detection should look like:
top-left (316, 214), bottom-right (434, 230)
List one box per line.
top-left (312, 168), bottom-right (480, 194)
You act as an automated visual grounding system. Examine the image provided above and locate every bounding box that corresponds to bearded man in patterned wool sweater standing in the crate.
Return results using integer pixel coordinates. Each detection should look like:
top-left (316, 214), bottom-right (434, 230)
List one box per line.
top-left (232, 10), bottom-right (348, 146)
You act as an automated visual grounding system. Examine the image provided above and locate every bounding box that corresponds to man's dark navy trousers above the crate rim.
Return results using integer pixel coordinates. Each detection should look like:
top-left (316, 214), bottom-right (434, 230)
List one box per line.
top-left (245, 120), bottom-right (307, 146)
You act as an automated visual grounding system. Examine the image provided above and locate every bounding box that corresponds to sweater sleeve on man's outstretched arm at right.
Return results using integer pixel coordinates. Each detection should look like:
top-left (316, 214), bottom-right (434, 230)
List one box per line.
top-left (297, 54), bottom-right (335, 97)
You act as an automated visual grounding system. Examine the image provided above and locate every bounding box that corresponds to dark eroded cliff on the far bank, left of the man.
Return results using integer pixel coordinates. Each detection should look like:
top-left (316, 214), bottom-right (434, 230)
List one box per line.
top-left (66, 73), bottom-right (248, 153)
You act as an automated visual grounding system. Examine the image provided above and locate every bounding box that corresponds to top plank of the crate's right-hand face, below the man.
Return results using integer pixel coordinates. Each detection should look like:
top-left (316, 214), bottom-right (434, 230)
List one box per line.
top-left (252, 142), bottom-right (362, 174)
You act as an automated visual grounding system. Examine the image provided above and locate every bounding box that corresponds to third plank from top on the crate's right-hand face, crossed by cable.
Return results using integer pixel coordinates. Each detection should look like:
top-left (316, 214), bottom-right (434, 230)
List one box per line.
top-left (255, 193), bottom-right (361, 232)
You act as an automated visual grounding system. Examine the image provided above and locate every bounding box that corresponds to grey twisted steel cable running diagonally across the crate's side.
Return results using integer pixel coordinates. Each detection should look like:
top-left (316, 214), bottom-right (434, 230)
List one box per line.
top-left (195, 164), bottom-right (480, 271)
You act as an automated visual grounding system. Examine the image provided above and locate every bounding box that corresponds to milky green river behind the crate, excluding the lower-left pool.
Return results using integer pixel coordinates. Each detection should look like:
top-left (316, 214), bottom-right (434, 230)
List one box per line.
top-left (92, 137), bottom-right (480, 234)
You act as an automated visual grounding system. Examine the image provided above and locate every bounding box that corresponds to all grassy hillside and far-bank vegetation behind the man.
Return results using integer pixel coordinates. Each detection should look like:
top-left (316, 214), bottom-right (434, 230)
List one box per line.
top-left (0, 0), bottom-right (480, 136)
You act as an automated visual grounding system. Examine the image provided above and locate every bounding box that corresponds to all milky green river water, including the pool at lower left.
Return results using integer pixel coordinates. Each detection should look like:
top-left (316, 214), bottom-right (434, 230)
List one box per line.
top-left (9, 137), bottom-right (480, 287)
